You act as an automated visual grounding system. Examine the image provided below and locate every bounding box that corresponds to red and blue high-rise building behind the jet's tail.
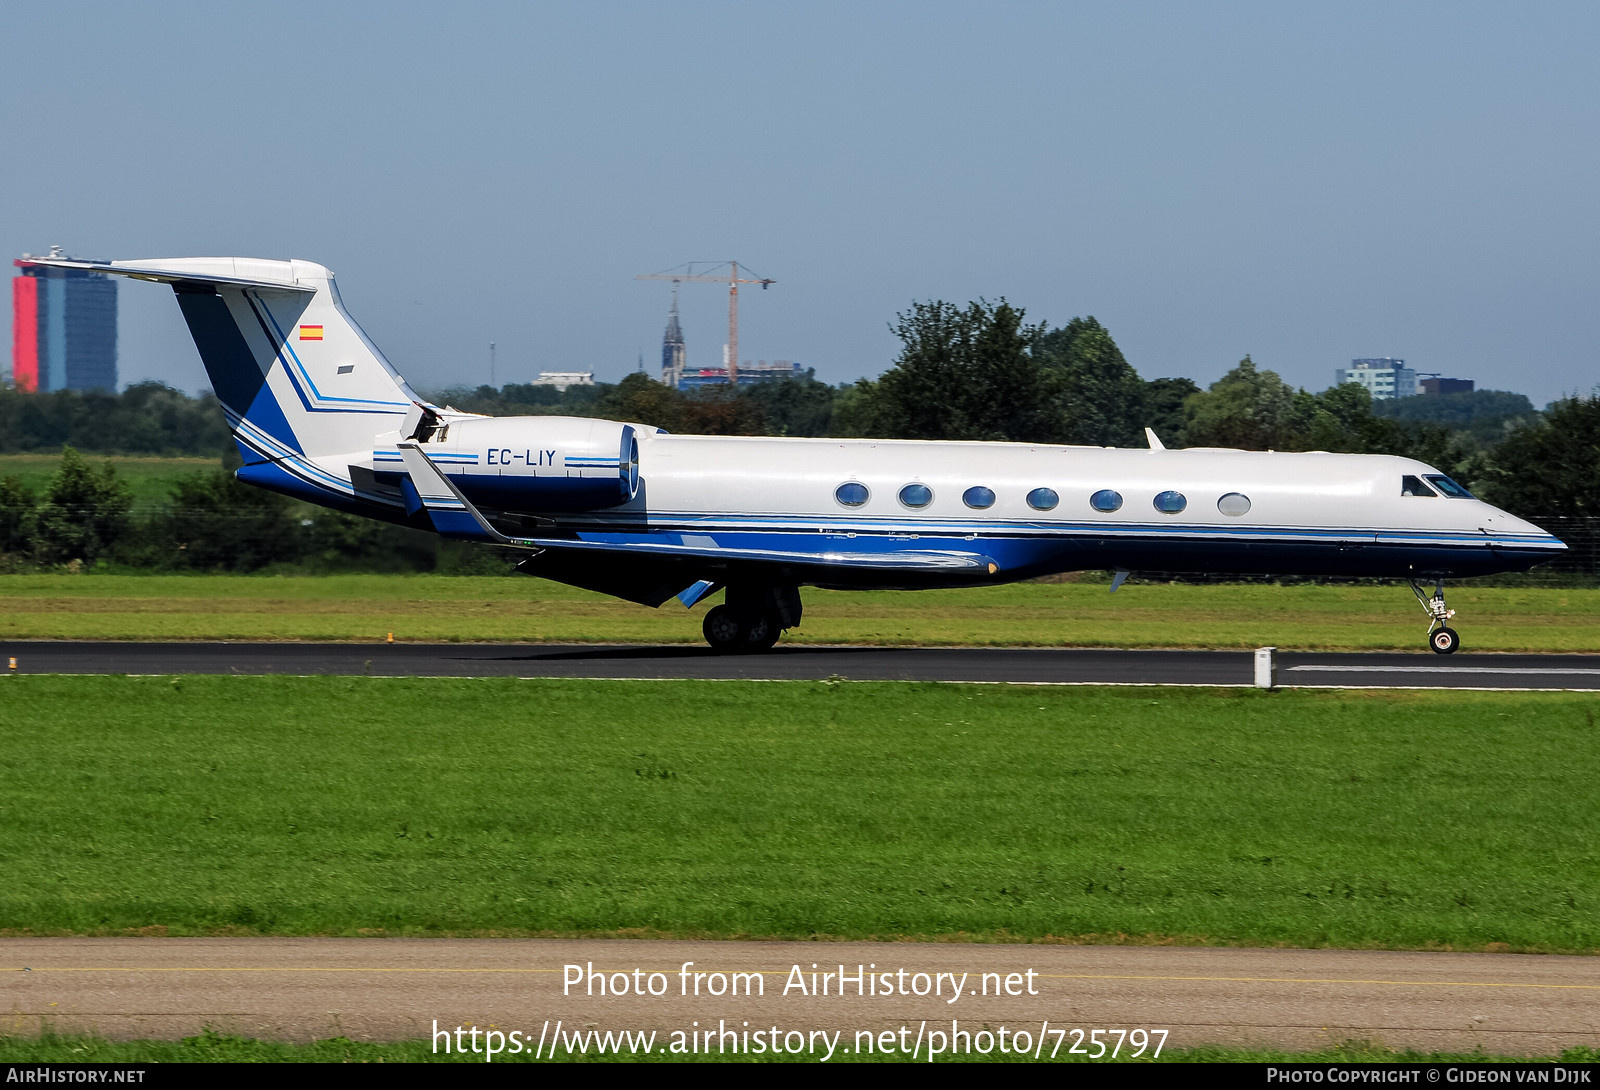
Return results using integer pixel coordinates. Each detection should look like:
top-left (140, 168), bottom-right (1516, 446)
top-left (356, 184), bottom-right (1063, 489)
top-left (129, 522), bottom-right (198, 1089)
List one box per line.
top-left (11, 250), bottom-right (117, 394)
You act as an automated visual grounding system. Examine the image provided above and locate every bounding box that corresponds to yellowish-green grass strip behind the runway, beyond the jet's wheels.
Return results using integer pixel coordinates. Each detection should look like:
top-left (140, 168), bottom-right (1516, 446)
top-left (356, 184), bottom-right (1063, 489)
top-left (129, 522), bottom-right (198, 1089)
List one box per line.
top-left (0, 575), bottom-right (1600, 651)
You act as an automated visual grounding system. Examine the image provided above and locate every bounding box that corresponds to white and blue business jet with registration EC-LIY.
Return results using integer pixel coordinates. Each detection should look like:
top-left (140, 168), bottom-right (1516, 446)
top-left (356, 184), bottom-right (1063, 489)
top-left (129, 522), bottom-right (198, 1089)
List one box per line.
top-left (32, 258), bottom-right (1566, 655)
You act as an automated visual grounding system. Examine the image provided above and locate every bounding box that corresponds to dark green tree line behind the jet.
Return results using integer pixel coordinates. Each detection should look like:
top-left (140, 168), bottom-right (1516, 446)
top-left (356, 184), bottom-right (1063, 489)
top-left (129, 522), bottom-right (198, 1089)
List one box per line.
top-left (0, 299), bottom-right (1600, 571)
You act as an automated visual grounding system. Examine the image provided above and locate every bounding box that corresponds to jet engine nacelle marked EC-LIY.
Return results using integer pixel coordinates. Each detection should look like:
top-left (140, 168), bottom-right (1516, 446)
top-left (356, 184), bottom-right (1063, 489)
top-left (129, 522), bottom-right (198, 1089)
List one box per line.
top-left (422, 416), bottom-right (638, 511)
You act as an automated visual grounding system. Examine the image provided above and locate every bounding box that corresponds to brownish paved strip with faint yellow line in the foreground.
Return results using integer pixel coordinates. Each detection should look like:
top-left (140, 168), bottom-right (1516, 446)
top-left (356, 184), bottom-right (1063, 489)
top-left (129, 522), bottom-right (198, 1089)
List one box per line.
top-left (0, 938), bottom-right (1600, 1058)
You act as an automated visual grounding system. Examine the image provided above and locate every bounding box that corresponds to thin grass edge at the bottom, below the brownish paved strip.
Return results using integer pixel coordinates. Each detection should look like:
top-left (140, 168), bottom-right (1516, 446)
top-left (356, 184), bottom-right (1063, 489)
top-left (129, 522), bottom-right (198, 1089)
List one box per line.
top-left (0, 1034), bottom-right (1580, 1064)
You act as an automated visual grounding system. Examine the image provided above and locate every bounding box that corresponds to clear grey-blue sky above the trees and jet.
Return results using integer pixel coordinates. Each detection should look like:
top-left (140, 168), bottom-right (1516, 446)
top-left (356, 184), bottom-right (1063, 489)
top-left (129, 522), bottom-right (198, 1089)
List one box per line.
top-left (0, 0), bottom-right (1600, 405)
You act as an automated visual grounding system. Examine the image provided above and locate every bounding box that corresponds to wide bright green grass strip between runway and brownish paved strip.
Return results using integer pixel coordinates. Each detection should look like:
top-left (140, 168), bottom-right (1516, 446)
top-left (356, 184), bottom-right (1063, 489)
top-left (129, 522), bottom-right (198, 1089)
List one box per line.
top-left (0, 675), bottom-right (1600, 951)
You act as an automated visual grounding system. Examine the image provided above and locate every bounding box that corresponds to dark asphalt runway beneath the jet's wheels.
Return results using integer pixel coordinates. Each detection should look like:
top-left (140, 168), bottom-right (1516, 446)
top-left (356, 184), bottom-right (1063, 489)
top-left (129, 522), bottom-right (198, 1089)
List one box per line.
top-left (0, 640), bottom-right (1600, 690)
